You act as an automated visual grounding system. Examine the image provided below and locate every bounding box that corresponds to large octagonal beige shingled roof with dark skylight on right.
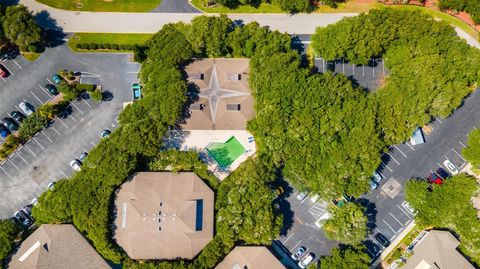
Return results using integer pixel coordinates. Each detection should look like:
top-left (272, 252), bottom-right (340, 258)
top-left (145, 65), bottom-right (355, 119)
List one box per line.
top-left (114, 172), bottom-right (214, 259)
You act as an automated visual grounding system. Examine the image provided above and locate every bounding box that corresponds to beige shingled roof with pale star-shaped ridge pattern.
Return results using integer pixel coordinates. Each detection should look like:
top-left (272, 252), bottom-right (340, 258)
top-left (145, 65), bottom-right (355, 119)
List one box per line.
top-left (182, 58), bottom-right (255, 130)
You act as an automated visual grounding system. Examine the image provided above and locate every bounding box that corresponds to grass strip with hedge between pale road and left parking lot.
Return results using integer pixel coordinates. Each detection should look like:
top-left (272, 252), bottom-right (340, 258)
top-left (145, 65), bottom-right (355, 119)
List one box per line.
top-left (68, 33), bottom-right (153, 52)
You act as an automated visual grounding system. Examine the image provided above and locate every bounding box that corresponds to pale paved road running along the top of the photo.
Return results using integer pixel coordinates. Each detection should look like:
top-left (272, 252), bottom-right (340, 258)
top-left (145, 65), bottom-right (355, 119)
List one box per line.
top-left (20, 0), bottom-right (357, 34)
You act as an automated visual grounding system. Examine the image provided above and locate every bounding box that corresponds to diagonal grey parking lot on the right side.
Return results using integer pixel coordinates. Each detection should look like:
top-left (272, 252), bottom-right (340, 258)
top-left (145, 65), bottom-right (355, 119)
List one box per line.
top-left (363, 90), bottom-right (480, 260)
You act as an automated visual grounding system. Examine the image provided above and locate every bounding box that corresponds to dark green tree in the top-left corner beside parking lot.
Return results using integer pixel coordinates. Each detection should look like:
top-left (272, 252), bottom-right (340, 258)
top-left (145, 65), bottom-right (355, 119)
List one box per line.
top-left (2, 5), bottom-right (44, 51)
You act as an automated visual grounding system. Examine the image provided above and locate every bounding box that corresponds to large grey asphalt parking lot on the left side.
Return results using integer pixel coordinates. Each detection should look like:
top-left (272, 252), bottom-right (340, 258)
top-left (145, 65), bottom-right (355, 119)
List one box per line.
top-left (0, 45), bottom-right (139, 218)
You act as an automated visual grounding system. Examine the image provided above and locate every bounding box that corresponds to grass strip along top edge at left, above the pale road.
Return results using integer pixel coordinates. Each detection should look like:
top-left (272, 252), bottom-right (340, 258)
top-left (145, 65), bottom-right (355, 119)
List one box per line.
top-left (36, 0), bottom-right (161, 12)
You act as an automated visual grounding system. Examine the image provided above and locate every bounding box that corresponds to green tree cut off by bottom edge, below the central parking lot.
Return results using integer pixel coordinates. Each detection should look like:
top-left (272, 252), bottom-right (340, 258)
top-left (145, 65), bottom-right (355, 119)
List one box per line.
top-left (319, 245), bottom-right (370, 269)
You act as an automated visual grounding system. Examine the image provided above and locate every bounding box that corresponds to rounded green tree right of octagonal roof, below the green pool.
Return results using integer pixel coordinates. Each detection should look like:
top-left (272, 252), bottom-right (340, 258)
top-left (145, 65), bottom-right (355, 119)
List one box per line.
top-left (215, 159), bottom-right (282, 244)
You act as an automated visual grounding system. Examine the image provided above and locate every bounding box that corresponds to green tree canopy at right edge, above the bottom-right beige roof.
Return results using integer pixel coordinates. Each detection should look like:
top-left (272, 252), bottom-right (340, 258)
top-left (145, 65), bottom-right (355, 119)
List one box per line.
top-left (405, 174), bottom-right (480, 263)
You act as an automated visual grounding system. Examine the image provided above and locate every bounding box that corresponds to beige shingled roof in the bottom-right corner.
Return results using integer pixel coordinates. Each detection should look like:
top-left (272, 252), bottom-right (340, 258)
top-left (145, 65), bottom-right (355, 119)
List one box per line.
top-left (402, 231), bottom-right (475, 269)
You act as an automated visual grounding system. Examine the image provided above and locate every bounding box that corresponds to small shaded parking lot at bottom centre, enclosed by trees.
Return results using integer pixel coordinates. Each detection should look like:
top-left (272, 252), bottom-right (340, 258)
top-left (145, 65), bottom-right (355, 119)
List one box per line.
top-left (276, 183), bottom-right (338, 266)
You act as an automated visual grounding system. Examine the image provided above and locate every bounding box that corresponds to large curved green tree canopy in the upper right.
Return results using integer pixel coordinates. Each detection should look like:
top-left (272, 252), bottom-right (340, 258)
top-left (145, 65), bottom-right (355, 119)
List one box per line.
top-left (312, 9), bottom-right (480, 144)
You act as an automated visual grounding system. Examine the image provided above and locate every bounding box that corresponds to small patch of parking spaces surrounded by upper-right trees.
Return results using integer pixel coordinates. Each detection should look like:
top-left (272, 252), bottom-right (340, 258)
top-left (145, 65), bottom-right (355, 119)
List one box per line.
top-left (315, 58), bottom-right (388, 90)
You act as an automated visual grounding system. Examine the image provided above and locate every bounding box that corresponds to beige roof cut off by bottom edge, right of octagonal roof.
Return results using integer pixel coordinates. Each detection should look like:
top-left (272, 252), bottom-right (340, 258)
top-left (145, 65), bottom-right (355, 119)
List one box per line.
top-left (215, 247), bottom-right (285, 269)
